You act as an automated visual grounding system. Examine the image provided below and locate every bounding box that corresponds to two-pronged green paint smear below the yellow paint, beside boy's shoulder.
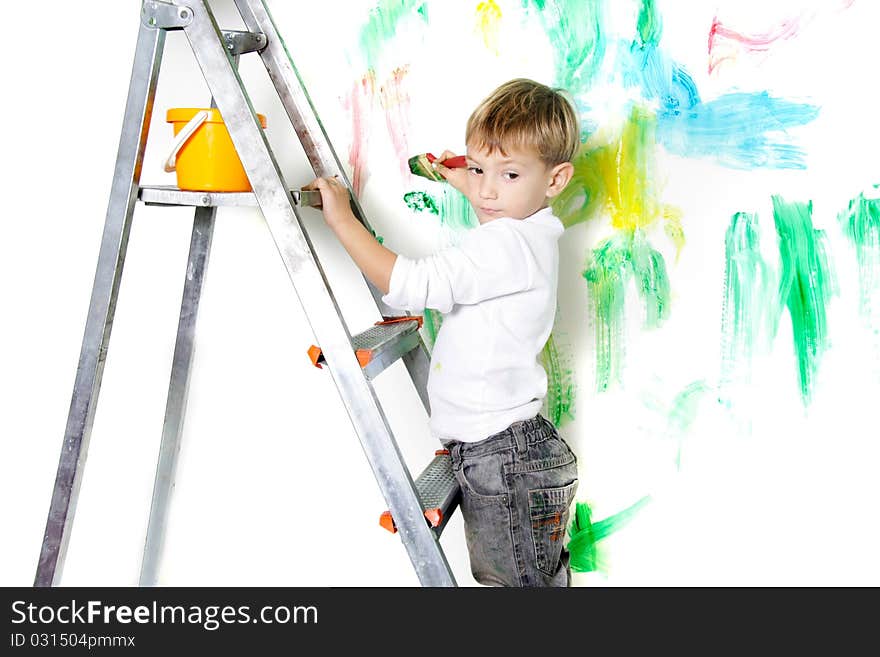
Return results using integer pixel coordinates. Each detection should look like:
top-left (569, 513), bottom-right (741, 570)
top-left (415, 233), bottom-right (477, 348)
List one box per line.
top-left (583, 230), bottom-right (670, 392)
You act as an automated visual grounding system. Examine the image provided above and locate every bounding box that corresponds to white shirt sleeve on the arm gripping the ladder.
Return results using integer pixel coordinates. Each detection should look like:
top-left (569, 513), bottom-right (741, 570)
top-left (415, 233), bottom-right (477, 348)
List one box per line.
top-left (382, 220), bottom-right (536, 313)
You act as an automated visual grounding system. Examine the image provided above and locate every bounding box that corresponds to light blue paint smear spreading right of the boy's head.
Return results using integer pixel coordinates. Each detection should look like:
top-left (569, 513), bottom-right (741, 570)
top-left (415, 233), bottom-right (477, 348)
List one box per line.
top-left (618, 42), bottom-right (819, 169)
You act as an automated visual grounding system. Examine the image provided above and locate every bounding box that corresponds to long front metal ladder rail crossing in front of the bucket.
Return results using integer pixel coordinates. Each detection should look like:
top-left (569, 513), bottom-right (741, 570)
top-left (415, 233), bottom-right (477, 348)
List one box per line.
top-left (183, 0), bottom-right (455, 586)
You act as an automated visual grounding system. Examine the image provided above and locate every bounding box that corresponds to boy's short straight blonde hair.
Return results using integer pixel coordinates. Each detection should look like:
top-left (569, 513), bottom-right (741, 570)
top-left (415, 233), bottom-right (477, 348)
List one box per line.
top-left (465, 78), bottom-right (580, 166)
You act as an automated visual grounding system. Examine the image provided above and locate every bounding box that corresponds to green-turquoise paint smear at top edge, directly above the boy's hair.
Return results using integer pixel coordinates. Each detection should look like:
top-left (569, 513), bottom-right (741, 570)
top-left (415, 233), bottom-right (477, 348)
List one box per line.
top-left (522, 0), bottom-right (605, 94)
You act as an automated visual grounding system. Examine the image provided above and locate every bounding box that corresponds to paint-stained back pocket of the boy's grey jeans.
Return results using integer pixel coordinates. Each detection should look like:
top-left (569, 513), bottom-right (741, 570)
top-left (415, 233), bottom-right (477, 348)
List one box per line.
top-left (529, 480), bottom-right (577, 575)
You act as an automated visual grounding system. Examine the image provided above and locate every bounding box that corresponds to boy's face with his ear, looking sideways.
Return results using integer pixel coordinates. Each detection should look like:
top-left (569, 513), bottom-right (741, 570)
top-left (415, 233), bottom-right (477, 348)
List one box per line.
top-left (464, 144), bottom-right (572, 224)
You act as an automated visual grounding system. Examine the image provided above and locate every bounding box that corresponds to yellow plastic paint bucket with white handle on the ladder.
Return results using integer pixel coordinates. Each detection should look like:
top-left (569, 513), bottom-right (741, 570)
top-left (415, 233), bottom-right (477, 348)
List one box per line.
top-left (165, 107), bottom-right (266, 192)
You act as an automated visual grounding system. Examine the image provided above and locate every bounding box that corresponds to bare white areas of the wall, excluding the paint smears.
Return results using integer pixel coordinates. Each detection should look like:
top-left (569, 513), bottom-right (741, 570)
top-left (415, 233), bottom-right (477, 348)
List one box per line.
top-left (6, 0), bottom-right (880, 586)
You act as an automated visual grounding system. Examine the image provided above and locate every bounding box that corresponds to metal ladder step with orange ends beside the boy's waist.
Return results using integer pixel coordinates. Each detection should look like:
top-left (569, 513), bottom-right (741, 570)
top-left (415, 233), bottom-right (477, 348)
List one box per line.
top-left (309, 315), bottom-right (424, 380)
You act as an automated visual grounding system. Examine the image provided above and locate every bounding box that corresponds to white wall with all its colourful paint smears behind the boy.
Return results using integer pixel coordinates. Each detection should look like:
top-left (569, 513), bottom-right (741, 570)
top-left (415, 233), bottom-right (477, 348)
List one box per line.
top-left (0, 0), bottom-right (880, 586)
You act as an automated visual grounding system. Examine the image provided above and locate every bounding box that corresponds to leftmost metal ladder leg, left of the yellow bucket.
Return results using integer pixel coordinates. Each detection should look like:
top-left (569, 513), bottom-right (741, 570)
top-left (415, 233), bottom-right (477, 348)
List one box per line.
top-left (34, 23), bottom-right (165, 586)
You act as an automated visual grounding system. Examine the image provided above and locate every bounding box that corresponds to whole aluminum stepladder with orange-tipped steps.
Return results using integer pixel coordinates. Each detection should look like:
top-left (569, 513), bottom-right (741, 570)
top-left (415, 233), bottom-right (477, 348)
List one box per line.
top-left (34, 0), bottom-right (459, 586)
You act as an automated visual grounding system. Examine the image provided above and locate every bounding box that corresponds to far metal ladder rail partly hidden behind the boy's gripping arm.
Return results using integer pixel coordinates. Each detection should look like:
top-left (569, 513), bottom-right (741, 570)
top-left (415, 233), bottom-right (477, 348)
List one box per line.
top-left (234, 0), bottom-right (431, 414)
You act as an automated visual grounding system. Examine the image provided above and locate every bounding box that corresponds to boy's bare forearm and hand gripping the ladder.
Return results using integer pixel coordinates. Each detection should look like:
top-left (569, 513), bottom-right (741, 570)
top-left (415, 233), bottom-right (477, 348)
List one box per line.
top-left (303, 178), bottom-right (397, 294)
